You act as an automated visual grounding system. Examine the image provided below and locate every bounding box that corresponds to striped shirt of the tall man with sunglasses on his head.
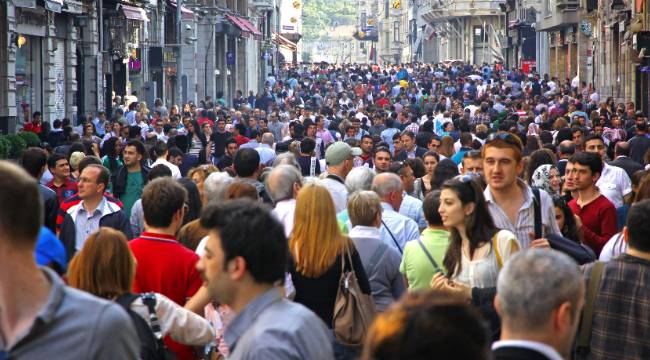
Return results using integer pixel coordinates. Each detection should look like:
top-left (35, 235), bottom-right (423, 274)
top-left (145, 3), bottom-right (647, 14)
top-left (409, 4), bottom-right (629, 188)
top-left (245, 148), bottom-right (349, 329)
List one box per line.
top-left (483, 179), bottom-right (561, 249)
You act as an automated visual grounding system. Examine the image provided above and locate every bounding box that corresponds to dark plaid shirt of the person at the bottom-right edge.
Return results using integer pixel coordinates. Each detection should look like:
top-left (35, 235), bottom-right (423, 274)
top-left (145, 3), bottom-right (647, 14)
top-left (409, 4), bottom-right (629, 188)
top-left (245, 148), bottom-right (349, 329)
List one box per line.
top-left (583, 254), bottom-right (650, 360)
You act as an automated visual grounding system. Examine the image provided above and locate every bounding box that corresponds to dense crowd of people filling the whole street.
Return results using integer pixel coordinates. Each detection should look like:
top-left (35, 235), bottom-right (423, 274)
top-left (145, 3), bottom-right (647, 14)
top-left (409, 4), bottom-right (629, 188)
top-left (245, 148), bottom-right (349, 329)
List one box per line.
top-left (0, 60), bottom-right (650, 360)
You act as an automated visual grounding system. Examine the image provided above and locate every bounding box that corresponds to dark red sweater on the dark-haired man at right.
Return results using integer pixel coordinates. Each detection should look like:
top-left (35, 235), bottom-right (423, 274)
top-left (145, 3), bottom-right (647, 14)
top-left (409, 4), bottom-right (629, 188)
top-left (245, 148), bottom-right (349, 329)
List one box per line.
top-left (569, 194), bottom-right (617, 255)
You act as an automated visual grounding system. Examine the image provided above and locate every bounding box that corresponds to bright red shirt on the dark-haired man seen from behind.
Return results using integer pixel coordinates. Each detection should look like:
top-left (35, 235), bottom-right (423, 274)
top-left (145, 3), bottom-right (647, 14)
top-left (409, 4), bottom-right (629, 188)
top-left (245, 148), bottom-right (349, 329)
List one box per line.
top-left (129, 231), bottom-right (203, 360)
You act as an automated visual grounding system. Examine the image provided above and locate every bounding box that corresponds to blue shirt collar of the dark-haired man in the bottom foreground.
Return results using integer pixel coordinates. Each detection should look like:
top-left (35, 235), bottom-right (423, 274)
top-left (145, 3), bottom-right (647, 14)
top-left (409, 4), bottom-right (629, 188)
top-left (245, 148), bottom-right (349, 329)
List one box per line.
top-left (224, 288), bottom-right (282, 353)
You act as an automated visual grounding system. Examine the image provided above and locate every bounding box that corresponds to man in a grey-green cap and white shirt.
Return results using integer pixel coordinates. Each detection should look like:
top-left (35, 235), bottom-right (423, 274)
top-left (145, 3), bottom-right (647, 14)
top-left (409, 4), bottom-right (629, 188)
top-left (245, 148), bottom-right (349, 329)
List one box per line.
top-left (323, 141), bottom-right (361, 213)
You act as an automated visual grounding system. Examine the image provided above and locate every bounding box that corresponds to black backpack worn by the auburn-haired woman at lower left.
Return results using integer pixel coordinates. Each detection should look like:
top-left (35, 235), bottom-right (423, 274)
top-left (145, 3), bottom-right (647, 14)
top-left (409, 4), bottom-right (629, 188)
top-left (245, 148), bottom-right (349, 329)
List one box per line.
top-left (115, 293), bottom-right (176, 360)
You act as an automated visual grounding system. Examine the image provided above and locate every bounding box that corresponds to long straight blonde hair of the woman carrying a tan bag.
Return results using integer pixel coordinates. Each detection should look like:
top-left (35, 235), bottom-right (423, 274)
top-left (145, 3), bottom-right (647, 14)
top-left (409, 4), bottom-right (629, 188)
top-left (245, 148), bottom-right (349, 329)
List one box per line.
top-left (289, 183), bottom-right (350, 277)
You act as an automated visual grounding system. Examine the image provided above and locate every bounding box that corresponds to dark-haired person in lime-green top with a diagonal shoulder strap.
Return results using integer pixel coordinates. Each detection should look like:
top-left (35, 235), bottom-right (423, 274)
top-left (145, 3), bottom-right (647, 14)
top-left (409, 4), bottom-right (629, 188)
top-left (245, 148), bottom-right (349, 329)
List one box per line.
top-left (400, 190), bottom-right (449, 290)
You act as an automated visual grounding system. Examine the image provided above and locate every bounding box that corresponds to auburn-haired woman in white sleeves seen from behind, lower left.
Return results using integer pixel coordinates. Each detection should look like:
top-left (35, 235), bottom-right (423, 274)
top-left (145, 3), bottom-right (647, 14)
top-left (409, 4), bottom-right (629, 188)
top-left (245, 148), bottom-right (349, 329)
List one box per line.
top-left (68, 227), bottom-right (215, 358)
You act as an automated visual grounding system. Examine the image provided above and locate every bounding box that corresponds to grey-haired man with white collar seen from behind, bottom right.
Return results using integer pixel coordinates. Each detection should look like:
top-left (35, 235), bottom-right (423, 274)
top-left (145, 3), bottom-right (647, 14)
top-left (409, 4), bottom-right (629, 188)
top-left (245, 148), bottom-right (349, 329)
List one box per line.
top-left (492, 249), bottom-right (585, 360)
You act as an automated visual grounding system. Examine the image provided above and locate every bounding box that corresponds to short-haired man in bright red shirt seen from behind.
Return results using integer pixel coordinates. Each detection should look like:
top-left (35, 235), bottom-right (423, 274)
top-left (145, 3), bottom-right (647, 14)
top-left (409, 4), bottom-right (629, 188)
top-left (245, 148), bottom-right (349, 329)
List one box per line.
top-left (129, 177), bottom-right (201, 359)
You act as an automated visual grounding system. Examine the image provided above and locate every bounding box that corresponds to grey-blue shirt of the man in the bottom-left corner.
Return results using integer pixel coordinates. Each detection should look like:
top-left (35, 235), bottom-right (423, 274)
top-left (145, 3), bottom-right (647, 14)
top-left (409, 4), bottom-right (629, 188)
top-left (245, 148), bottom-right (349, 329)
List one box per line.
top-left (0, 268), bottom-right (140, 359)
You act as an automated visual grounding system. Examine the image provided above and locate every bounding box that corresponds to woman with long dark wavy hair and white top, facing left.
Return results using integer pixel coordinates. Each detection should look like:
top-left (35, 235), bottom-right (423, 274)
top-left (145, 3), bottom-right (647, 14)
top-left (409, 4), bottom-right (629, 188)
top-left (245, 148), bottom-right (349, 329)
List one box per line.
top-left (438, 176), bottom-right (520, 288)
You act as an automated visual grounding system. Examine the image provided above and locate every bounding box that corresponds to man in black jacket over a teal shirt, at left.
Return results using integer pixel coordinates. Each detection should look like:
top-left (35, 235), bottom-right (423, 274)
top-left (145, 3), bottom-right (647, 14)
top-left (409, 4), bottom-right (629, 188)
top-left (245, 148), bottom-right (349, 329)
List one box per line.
top-left (112, 140), bottom-right (149, 218)
